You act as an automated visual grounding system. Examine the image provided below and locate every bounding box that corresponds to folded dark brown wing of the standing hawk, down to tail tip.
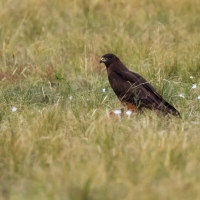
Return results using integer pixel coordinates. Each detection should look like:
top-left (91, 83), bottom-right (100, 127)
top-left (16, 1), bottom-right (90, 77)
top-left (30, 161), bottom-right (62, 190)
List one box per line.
top-left (109, 69), bottom-right (180, 117)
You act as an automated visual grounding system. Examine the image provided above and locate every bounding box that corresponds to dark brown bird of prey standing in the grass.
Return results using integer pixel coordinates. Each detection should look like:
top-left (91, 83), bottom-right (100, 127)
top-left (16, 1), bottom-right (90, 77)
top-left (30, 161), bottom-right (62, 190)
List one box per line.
top-left (100, 54), bottom-right (181, 118)
